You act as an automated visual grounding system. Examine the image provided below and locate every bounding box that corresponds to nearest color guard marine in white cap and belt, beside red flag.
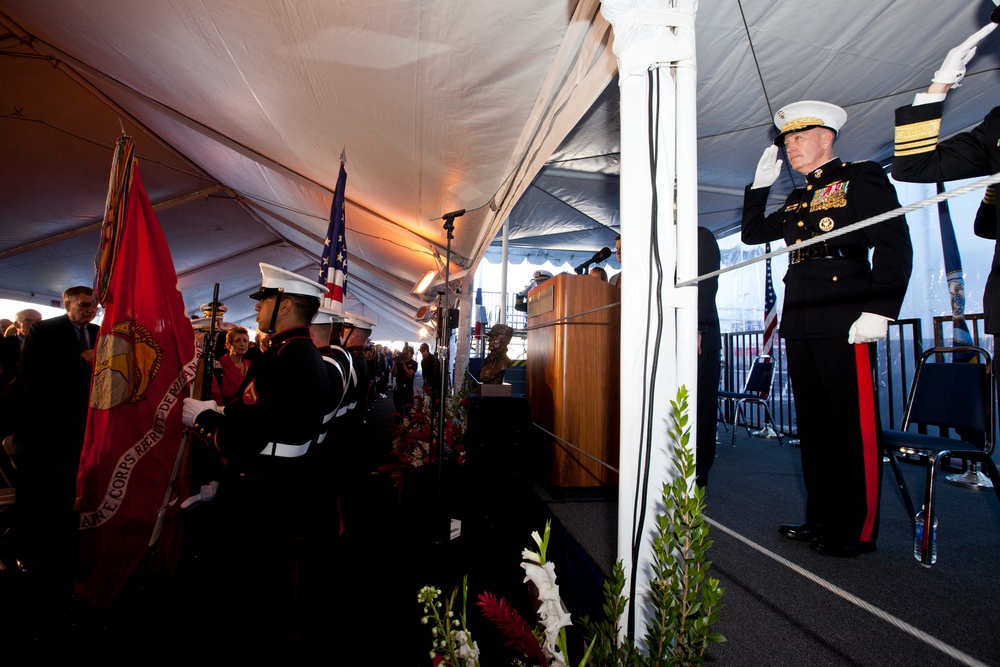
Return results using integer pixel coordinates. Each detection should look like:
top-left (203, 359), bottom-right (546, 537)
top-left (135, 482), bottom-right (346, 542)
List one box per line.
top-left (184, 263), bottom-right (330, 544)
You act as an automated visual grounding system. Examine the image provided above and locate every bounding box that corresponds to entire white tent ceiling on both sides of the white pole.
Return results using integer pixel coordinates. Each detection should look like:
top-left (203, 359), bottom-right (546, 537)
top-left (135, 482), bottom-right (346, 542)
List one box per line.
top-left (0, 0), bottom-right (1000, 339)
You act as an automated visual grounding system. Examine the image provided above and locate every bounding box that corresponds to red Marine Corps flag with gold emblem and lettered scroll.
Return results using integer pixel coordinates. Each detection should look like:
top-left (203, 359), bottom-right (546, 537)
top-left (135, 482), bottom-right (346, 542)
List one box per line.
top-left (76, 137), bottom-right (196, 607)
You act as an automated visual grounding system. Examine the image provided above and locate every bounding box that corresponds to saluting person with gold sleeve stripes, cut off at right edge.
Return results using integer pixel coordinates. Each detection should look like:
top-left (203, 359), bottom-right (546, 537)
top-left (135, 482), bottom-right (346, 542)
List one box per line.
top-left (892, 22), bottom-right (1000, 335)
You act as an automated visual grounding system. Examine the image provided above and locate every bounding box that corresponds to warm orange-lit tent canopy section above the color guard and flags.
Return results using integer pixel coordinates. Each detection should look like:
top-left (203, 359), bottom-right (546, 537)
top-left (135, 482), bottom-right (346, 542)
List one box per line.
top-left (0, 0), bottom-right (611, 339)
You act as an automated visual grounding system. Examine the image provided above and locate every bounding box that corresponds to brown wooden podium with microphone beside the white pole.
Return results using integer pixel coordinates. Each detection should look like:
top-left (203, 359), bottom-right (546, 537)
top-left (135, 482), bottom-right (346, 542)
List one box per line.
top-left (528, 273), bottom-right (621, 487)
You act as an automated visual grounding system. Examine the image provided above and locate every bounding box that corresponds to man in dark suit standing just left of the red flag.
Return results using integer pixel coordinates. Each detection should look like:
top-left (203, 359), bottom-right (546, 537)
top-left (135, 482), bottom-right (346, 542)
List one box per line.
top-left (14, 286), bottom-right (98, 598)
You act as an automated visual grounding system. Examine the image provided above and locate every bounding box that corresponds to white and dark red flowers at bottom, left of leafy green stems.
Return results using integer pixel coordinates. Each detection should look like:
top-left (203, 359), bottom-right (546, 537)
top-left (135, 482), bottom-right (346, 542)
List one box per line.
top-left (417, 522), bottom-right (590, 667)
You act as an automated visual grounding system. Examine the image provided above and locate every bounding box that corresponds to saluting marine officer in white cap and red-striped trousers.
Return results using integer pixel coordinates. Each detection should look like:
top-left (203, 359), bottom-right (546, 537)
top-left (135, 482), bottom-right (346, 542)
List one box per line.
top-left (742, 101), bottom-right (913, 557)
